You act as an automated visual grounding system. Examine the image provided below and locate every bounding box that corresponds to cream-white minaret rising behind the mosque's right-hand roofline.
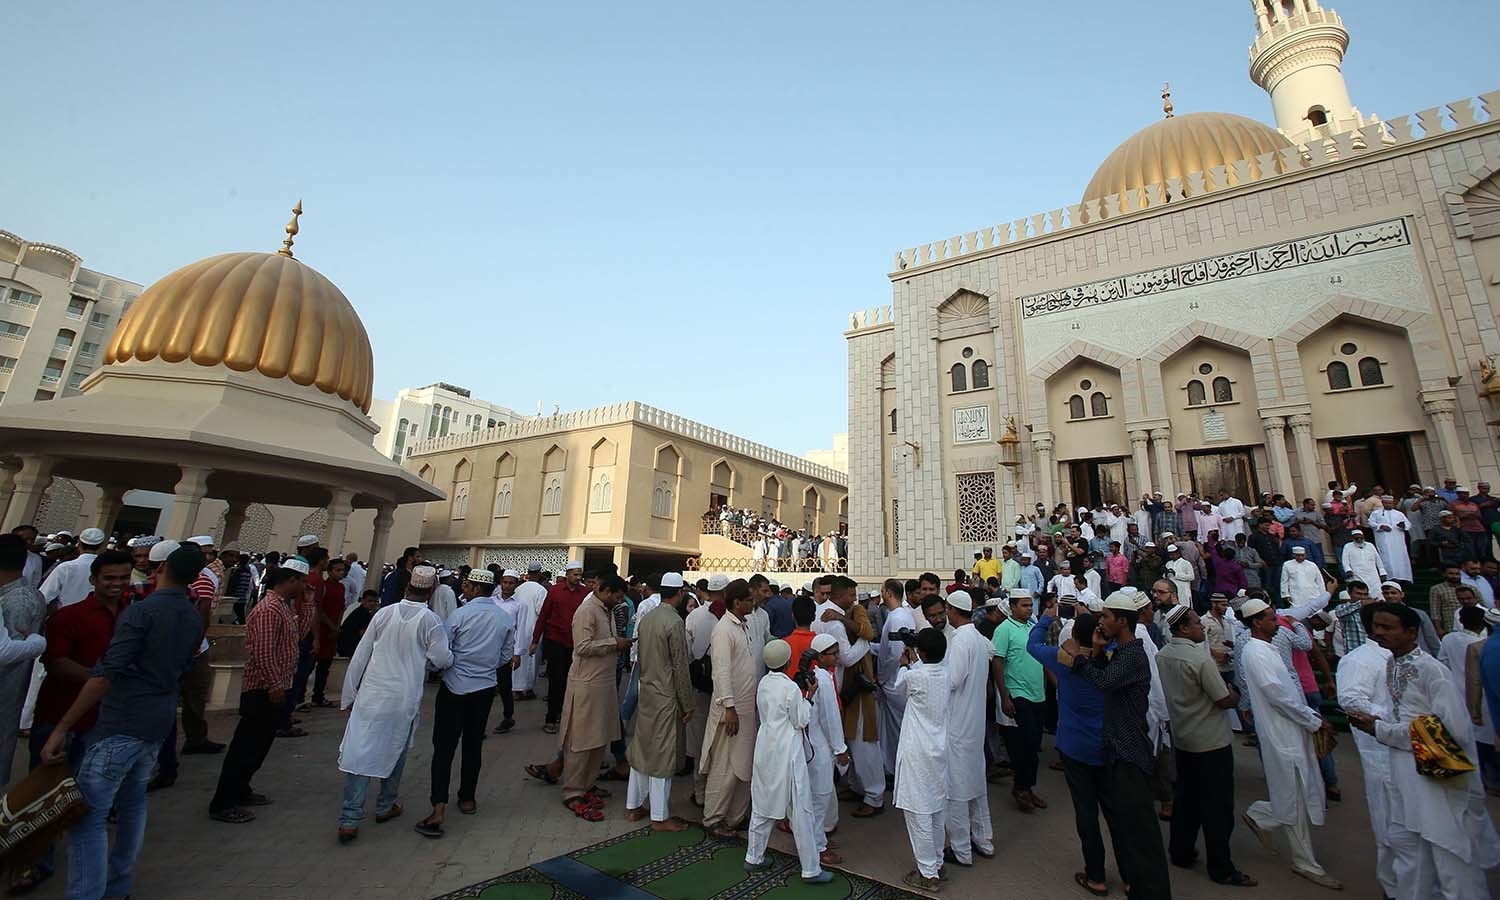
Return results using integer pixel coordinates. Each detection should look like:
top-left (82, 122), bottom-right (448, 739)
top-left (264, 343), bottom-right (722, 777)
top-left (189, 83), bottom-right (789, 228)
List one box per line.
top-left (1250, 0), bottom-right (1376, 144)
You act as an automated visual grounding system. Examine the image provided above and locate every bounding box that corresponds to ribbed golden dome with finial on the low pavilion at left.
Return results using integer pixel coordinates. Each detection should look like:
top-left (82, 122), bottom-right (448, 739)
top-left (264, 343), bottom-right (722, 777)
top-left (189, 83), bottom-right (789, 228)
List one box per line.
top-left (105, 247), bottom-right (375, 413)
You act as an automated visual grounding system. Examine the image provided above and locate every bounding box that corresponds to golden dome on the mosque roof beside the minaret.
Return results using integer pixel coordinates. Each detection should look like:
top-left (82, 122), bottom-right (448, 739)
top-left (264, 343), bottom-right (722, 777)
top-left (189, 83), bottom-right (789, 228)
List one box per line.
top-left (1083, 113), bottom-right (1292, 201)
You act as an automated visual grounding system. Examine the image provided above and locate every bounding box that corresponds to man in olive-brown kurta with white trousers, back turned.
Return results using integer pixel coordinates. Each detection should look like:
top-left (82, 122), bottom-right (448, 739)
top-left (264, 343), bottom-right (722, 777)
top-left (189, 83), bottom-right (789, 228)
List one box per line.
top-left (626, 587), bottom-right (693, 831)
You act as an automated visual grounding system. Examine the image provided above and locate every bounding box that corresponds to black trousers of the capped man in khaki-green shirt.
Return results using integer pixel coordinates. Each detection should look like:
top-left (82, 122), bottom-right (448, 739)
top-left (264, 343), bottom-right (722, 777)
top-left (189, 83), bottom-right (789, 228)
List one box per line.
top-left (1169, 747), bottom-right (1235, 881)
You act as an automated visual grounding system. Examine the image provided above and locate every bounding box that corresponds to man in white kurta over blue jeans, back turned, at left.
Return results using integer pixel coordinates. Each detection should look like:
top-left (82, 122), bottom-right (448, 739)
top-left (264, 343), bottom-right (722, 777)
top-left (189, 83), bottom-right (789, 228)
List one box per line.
top-left (339, 566), bottom-right (453, 842)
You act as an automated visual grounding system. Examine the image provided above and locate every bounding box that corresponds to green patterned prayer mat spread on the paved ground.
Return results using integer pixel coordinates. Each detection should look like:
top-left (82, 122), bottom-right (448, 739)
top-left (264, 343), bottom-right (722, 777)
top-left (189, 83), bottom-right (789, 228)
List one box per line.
top-left (435, 827), bottom-right (923, 900)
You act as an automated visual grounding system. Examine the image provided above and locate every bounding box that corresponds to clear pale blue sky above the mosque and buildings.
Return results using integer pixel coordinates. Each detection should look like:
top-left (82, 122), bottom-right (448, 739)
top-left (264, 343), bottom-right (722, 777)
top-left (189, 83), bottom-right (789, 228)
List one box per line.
top-left (0, 0), bottom-right (1500, 453)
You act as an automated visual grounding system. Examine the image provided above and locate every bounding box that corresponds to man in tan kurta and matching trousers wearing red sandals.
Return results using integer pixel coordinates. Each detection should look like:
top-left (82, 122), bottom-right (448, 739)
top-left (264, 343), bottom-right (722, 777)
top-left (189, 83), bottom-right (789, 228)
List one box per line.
top-left (560, 576), bottom-right (630, 803)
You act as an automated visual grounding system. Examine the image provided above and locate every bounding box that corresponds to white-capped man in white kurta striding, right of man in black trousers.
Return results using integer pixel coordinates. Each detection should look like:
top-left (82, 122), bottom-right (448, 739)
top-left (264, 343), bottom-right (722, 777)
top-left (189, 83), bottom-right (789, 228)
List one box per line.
top-left (1239, 599), bottom-right (1343, 890)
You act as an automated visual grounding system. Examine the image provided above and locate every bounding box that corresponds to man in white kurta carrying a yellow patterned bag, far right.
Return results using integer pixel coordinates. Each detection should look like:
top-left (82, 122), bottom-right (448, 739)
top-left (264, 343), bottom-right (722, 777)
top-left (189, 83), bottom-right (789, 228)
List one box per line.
top-left (1350, 605), bottom-right (1500, 900)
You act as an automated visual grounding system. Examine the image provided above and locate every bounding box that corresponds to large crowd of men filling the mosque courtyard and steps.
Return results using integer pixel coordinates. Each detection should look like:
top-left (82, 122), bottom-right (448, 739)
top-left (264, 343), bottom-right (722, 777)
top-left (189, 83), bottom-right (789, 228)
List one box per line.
top-left (0, 483), bottom-right (1500, 900)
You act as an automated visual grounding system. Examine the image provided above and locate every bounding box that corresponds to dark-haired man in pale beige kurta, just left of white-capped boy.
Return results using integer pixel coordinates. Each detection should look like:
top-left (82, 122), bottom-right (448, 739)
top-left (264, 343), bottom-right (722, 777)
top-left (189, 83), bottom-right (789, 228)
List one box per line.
top-left (698, 579), bottom-right (761, 837)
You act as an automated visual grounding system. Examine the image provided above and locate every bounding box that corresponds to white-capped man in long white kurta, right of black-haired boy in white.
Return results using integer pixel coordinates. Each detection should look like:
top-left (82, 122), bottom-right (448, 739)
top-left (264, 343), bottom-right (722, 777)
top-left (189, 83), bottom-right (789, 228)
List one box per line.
top-left (945, 591), bottom-right (995, 866)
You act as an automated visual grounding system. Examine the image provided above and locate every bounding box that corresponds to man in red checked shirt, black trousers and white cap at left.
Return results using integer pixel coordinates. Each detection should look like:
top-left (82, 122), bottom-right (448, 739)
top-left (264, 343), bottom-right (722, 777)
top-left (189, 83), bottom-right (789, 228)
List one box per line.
top-left (209, 557), bottom-right (312, 825)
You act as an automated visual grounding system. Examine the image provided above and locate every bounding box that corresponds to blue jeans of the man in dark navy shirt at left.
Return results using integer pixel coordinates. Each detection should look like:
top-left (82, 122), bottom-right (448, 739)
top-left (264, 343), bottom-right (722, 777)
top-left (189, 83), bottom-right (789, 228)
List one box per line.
top-left (68, 735), bottom-right (162, 900)
